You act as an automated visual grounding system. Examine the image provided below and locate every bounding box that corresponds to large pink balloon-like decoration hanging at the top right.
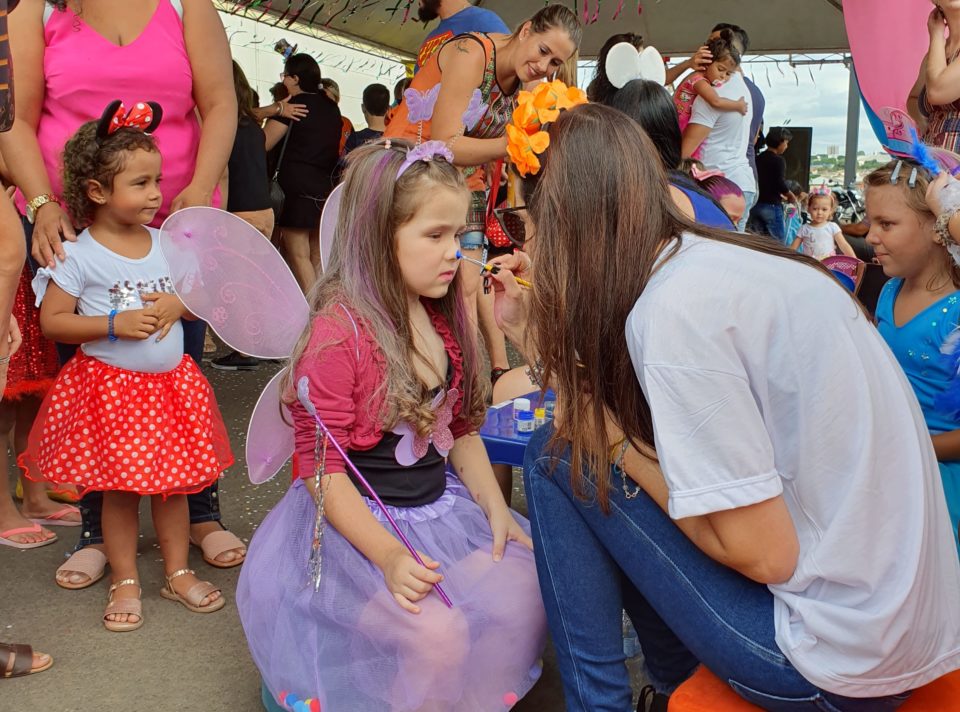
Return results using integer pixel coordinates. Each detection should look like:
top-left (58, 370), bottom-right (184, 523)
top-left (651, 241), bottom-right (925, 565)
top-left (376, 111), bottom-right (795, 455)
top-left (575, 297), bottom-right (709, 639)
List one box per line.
top-left (843, 0), bottom-right (933, 111)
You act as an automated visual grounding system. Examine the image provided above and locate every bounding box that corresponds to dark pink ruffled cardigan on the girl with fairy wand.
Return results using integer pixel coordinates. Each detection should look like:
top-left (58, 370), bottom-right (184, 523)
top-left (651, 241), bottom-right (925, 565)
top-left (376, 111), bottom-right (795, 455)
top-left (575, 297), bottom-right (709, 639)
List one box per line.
top-left (290, 304), bottom-right (474, 478)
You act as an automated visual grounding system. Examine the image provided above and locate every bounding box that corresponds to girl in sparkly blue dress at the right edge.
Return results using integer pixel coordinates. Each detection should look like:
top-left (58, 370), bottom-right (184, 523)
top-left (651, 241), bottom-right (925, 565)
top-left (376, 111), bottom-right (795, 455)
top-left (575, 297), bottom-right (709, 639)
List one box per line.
top-left (864, 161), bottom-right (960, 552)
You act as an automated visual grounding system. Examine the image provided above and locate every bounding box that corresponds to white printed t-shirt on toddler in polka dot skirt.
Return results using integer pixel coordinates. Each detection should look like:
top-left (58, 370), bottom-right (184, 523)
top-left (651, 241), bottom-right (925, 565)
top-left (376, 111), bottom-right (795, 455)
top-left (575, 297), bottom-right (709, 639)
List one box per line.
top-left (33, 227), bottom-right (183, 373)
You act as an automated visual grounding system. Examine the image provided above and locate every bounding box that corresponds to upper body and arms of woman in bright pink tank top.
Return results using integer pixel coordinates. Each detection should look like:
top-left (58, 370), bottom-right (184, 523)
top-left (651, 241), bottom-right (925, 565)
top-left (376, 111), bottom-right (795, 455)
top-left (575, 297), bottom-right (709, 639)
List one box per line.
top-left (0, 0), bottom-right (237, 267)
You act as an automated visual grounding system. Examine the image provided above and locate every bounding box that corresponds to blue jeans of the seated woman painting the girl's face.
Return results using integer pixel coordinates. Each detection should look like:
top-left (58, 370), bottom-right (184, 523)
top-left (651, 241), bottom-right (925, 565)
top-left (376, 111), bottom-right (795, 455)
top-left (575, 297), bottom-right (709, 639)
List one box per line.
top-left (523, 426), bottom-right (909, 712)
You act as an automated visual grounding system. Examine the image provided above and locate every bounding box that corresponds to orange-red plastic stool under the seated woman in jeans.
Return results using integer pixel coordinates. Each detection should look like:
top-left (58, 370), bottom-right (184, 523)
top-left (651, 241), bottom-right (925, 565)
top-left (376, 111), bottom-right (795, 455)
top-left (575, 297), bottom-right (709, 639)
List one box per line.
top-left (669, 665), bottom-right (960, 712)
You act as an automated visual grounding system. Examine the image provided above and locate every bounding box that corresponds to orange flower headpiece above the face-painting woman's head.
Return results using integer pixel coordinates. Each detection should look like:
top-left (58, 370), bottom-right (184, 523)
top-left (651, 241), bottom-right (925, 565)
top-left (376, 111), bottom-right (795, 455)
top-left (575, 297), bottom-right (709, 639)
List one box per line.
top-left (507, 80), bottom-right (587, 176)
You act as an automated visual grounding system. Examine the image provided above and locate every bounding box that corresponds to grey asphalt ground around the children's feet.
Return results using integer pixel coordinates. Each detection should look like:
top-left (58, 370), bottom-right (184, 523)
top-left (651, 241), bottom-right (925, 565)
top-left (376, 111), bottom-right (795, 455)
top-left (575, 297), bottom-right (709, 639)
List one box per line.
top-left (0, 364), bottom-right (638, 712)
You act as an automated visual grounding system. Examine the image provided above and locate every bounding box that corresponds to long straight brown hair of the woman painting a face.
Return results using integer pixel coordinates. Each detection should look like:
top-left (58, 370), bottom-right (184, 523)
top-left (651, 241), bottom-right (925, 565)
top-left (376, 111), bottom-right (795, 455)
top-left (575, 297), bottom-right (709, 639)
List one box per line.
top-left (524, 104), bottom-right (844, 511)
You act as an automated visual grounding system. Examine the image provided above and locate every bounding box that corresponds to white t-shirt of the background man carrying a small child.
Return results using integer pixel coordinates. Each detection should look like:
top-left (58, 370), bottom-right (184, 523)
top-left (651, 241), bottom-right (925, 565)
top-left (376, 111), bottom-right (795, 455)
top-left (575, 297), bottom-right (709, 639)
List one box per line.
top-left (690, 72), bottom-right (757, 193)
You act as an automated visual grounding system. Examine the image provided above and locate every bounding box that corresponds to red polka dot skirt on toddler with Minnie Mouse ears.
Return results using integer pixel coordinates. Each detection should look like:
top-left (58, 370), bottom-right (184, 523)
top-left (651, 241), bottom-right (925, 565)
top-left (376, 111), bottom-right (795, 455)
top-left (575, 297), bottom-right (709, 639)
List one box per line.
top-left (19, 351), bottom-right (233, 495)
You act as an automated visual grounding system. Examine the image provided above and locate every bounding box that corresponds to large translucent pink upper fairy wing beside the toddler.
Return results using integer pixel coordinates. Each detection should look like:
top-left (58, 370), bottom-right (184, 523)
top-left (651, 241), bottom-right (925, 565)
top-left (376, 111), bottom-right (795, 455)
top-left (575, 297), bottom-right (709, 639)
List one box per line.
top-left (160, 207), bottom-right (310, 359)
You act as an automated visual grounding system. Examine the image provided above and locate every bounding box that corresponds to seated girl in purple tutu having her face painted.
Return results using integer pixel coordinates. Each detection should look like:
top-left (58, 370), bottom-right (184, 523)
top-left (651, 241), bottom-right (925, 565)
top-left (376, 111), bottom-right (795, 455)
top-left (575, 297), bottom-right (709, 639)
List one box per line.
top-left (237, 139), bottom-right (546, 712)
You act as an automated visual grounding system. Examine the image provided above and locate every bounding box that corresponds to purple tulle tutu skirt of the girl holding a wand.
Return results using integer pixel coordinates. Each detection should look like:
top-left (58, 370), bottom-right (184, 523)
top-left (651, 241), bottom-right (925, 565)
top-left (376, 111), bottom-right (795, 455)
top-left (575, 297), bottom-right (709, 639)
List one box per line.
top-left (237, 477), bottom-right (547, 712)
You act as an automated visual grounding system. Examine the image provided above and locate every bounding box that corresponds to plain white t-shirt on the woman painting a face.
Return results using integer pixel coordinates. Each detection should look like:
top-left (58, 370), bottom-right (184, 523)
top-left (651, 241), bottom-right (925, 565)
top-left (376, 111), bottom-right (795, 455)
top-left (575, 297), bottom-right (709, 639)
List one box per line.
top-left (626, 235), bottom-right (960, 697)
